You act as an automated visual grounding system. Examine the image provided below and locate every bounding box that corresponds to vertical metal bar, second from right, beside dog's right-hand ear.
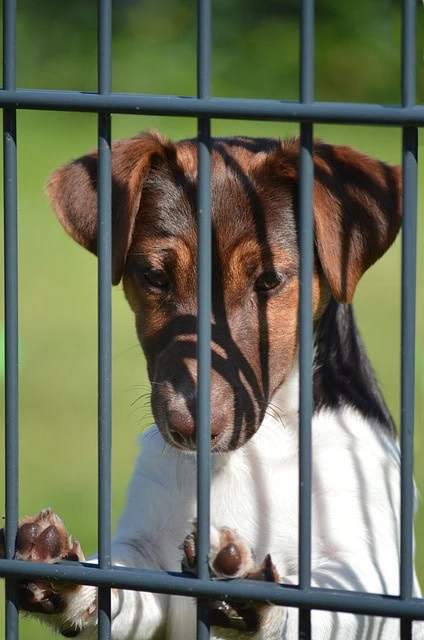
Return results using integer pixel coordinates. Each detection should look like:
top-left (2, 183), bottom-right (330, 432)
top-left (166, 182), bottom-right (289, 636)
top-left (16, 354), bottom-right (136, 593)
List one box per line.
top-left (299, 0), bottom-right (314, 640)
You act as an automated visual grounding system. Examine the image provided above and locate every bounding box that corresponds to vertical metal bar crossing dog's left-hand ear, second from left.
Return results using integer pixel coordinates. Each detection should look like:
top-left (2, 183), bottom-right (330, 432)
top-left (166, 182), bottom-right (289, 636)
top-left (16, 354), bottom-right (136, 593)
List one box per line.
top-left (97, 0), bottom-right (112, 640)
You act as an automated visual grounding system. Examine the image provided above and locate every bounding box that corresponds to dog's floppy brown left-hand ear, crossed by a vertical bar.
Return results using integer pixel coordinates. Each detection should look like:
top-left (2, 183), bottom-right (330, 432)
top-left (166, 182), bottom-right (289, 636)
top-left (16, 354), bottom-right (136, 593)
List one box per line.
top-left (47, 132), bottom-right (175, 284)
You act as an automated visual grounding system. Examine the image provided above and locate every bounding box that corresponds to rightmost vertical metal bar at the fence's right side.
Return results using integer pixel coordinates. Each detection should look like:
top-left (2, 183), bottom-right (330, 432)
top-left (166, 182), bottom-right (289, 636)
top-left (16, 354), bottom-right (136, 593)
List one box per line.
top-left (400, 0), bottom-right (418, 640)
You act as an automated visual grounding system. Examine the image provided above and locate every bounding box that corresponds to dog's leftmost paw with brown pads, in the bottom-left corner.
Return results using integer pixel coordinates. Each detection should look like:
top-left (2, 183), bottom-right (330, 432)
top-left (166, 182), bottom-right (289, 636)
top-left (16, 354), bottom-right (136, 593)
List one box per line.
top-left (0, 509), bottom-right (96, 637)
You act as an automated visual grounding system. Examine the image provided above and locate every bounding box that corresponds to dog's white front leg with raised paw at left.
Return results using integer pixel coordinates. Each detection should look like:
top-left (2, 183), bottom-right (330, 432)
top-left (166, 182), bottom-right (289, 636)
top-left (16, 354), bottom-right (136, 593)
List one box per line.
top-left (0, 509), bottom-right (168, 640)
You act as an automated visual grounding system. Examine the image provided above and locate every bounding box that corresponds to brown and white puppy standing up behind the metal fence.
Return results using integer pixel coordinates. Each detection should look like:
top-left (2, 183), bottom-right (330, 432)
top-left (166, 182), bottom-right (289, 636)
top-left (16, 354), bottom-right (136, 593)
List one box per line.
top-left (1, 132), bottom-right (424, 640)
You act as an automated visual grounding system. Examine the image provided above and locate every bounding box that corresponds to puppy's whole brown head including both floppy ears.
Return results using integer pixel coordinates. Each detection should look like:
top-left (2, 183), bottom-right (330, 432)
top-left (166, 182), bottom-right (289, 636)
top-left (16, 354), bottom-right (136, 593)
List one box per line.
top-left (49, 134), bottom-right (400, 451)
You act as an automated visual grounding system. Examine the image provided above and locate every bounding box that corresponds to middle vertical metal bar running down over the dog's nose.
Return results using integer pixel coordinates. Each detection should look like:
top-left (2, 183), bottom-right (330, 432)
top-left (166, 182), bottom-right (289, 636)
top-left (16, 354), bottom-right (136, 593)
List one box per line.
top-left (196, 0), bottom-right (212, 640)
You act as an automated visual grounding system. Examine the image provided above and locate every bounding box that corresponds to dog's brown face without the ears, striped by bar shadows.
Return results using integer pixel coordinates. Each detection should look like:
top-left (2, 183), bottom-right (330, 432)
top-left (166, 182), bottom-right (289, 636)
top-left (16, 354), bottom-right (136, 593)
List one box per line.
top-left (123, 142), bottom-right (308, 450)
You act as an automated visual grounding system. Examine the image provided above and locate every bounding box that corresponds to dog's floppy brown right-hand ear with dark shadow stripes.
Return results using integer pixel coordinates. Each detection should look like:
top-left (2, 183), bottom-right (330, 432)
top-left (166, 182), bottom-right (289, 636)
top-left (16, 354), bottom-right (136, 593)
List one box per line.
top-left (314, 142), bottom-right (402, 303)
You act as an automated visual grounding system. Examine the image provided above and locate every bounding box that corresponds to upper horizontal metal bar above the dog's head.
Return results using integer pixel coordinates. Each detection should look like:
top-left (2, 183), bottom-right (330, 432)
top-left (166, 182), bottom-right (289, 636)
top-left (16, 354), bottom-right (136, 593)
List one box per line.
top-left (0, 89), bottom-right (424, 126)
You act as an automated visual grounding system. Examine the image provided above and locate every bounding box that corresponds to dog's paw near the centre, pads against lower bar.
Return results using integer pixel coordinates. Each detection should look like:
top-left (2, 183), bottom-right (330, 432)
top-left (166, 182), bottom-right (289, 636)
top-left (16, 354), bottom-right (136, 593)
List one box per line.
top-left (182, 528), bottom-right (280, 633)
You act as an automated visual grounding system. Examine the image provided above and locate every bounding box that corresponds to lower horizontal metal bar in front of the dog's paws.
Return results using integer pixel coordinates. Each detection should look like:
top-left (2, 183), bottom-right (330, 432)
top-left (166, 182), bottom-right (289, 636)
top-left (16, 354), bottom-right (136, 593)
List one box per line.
top-left (0, 560), bottom-right (424, 620)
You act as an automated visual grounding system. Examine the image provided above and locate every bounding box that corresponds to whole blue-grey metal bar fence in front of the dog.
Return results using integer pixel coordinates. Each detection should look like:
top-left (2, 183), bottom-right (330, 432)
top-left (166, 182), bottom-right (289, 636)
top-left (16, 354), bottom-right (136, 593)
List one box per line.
top-left (0, 0), bottom-right (424, 640)
